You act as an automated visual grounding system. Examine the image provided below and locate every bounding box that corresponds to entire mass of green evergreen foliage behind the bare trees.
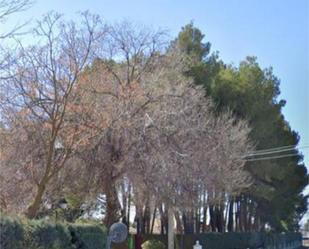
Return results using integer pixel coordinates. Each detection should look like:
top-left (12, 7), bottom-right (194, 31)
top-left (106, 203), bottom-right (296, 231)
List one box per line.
top-left (174, 23), bottom-right (309, 231)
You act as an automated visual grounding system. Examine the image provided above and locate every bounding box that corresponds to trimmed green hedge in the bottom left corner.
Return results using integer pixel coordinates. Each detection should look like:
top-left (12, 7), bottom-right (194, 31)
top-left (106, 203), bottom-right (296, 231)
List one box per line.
top-left (0, 216), bottom-right (106, 249)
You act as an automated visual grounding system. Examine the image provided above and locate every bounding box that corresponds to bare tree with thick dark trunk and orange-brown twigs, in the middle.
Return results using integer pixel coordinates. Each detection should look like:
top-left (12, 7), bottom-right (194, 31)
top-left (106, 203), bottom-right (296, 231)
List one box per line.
top-left (72, 23), bottom-right (164, 225)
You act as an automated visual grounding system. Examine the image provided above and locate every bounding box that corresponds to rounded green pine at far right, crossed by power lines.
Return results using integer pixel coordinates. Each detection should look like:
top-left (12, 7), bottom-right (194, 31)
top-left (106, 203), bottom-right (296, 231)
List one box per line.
top-left (212, 57), bottom-right (308, 231)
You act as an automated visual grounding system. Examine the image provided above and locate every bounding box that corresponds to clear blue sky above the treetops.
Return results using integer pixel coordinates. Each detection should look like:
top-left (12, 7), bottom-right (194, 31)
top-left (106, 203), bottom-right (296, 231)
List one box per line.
top-left (9, 0), bottom-right (309, 169)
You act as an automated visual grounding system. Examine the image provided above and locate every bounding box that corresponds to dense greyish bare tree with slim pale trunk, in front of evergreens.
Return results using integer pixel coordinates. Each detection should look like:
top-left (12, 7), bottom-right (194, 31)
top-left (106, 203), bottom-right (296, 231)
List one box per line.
top-left (124, 48), bottom-right (252, 248)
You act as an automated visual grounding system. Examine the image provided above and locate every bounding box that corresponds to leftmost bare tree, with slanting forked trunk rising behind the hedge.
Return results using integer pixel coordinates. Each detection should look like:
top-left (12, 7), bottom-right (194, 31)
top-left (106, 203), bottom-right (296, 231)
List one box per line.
top-left (1, 13), bottom-right (104, 218)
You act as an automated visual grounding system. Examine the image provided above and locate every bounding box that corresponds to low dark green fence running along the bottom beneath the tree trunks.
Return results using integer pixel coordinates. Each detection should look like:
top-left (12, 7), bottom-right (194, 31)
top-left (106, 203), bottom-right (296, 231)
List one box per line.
top-left (113, 232), bottom-right (302, 249)
